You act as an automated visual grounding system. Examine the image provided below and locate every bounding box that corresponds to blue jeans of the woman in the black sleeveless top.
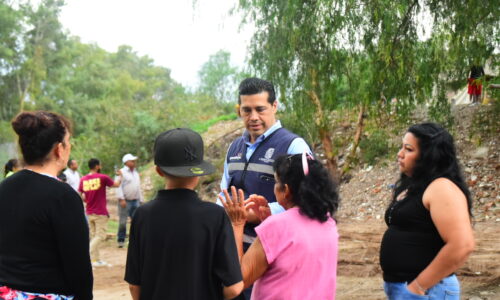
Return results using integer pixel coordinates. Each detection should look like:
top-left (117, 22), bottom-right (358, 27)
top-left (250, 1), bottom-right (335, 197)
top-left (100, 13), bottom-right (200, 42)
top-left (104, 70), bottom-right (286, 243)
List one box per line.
top-left (384, 275), bottom-right (460, 300)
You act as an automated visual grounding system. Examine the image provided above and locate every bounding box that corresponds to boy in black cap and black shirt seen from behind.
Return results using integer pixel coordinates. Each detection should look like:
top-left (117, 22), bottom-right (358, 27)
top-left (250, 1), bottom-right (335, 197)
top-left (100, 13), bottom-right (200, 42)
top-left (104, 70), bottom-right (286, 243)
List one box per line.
top-left (125, 128), bottom-right (243, 300)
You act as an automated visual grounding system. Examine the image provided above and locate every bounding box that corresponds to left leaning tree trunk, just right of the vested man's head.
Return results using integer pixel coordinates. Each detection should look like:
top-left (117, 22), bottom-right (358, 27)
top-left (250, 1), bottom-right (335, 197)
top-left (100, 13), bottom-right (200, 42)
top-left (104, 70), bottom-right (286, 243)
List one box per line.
top-left (307, 70), bottom-right (340, 181)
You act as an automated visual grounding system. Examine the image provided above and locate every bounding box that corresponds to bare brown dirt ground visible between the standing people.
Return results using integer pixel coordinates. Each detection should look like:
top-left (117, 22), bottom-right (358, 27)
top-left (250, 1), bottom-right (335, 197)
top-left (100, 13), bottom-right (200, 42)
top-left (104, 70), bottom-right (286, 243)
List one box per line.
top-left (94, 201), bottom-right (500, 300)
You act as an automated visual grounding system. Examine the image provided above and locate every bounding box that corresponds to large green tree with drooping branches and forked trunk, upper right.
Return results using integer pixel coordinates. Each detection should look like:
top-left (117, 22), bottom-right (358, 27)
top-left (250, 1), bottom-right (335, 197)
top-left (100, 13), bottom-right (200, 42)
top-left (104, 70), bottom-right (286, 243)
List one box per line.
top-left (238, 0), bottom-right (500, 176)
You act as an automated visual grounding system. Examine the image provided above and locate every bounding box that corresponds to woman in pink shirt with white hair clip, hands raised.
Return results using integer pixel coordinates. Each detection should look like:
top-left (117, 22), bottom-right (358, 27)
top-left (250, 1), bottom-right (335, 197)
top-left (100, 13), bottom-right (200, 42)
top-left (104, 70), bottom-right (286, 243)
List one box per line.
top-left (219, 153), bottom-right (339, 300)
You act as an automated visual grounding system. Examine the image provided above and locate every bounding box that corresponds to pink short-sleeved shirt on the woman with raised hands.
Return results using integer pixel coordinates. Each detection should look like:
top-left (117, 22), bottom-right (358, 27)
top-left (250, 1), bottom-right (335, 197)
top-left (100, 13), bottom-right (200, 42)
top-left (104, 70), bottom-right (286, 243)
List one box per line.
top-left (252, 207), bottom-right (339, 300)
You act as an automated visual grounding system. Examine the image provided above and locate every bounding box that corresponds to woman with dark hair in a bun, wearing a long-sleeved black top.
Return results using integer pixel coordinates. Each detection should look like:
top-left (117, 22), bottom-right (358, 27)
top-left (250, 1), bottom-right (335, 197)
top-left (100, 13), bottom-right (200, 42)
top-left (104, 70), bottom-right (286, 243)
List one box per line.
top-left (0, 111), bottom-right (93, 300)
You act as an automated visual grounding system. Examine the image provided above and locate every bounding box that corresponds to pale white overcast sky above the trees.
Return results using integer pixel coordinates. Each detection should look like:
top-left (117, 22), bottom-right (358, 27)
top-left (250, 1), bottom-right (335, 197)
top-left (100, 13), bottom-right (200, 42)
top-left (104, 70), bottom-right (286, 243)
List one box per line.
top-left (60, 0), bottom-right (253, 87)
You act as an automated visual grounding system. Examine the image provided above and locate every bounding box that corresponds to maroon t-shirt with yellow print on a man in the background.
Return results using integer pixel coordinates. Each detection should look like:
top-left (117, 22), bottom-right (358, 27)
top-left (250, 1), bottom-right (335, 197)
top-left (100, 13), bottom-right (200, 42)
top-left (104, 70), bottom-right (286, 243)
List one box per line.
top-left (78, 173), bottom-right (114, 216)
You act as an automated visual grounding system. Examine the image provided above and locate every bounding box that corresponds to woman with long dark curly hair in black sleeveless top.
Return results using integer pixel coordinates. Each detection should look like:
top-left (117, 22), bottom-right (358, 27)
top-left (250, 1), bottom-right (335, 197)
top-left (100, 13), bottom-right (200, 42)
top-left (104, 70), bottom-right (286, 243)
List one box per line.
top-left (380, 123), bottom-right (474, 300)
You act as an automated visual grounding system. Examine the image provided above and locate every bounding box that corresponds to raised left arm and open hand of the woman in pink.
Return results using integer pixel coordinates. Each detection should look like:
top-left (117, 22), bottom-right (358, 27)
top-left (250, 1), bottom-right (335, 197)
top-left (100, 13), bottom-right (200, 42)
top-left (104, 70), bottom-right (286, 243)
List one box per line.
top-left (221, 187), bottom-right (269, 288)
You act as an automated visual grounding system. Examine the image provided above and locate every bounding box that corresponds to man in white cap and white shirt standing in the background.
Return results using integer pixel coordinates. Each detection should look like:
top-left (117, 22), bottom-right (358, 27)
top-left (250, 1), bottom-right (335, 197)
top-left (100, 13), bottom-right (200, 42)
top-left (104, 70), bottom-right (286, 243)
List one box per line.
top-left (116, 153), bottom-right (143, 248)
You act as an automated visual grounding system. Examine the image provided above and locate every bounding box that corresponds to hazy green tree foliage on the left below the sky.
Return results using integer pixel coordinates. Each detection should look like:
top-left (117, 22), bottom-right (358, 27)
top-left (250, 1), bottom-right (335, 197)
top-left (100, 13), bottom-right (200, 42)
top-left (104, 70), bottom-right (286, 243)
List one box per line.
top-left (0, 0), bottom-right (232, 172)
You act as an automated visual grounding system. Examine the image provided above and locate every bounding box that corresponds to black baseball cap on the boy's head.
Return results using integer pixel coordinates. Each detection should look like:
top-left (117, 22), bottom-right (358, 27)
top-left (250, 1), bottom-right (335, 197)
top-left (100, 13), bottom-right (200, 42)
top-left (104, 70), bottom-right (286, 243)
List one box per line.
top-left (153, 128), bottom-right (215, 177)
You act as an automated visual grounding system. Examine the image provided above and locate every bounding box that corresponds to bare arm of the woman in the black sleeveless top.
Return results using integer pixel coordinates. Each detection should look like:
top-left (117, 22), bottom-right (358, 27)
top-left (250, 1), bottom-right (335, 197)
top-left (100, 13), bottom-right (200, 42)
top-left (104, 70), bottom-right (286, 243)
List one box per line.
top-left (408, 178), bottom-right (475, 295)
